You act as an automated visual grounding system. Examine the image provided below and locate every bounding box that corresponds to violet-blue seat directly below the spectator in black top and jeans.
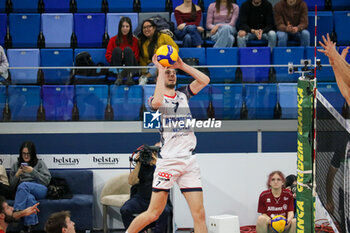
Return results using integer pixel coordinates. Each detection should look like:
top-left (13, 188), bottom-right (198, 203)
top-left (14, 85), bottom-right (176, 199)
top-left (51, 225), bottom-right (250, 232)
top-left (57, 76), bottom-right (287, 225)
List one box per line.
top-left (239, 47), bottom-right (271, 82)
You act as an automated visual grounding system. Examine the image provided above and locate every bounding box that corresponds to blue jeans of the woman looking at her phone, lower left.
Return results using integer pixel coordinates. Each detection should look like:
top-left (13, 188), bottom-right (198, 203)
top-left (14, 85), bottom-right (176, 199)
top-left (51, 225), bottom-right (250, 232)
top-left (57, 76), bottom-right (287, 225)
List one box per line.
top-left (14, 182), bottom-right (47, 226)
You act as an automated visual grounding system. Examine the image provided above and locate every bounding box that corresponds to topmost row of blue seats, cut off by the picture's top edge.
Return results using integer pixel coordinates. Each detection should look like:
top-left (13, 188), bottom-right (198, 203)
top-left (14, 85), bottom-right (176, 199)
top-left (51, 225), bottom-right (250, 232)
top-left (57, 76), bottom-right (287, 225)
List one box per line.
top-left (0, 0), bottom-right (350, 12)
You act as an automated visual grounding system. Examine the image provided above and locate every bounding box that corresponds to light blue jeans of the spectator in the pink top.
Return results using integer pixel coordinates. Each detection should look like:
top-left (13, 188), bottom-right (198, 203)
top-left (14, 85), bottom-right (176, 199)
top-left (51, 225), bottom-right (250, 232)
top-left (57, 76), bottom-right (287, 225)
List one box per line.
top-left (211, 24), bottom-right (237, 48)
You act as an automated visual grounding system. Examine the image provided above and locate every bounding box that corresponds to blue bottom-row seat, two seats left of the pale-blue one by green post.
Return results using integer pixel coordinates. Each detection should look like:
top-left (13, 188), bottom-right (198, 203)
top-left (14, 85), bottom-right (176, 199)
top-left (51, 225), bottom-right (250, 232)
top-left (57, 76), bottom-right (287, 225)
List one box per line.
top-left (211, 84), bottom-right (243, 120)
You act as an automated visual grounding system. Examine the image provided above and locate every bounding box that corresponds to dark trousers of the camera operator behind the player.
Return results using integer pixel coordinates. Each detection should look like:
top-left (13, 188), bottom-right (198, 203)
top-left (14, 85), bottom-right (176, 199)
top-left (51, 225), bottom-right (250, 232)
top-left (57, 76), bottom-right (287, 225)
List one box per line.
top-left (120, 194), bottom-right (172, 233)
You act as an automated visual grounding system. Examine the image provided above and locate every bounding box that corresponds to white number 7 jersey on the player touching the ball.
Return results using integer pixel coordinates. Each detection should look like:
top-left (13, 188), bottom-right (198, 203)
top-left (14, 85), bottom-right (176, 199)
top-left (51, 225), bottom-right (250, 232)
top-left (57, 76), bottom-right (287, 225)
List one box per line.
top-left (149, 85), bottom-right (197, 158)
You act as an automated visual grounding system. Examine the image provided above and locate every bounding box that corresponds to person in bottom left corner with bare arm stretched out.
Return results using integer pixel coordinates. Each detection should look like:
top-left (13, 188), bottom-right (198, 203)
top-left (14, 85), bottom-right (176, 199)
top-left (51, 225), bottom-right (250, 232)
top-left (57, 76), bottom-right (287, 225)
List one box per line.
top-left (0, 196), bottom-right (39, 233)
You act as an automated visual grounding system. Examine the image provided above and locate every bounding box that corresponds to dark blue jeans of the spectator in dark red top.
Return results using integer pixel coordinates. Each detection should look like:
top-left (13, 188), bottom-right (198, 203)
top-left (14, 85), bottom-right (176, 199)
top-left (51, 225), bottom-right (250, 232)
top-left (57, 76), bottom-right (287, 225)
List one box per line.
top-left (175, 25), bottom-right (203, 47)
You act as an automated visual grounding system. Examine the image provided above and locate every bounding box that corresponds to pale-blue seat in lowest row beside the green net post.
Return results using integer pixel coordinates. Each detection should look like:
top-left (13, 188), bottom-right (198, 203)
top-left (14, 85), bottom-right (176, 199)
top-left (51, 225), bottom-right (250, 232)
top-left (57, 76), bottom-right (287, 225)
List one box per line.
top-left (278, 83), bottom-right (298, 119)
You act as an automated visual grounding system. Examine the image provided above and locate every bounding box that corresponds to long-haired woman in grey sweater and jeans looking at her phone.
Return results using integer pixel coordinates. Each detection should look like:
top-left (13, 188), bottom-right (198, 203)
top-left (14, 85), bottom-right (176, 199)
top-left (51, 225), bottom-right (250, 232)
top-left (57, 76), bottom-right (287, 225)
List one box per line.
top-left (10, 142), bottom-right (51, 231)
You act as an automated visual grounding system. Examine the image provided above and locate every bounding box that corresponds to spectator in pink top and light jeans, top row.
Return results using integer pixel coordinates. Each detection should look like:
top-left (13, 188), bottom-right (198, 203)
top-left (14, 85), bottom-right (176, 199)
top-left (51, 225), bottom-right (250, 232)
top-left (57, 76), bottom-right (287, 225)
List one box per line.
top-left (207, 0), bottom-right (239, 47)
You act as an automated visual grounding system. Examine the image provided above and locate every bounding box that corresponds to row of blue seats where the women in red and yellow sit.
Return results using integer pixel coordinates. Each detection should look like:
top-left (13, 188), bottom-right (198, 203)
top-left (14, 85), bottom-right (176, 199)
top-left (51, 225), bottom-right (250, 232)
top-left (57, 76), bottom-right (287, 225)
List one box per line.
top-left (0, 11), bottom-right (350, 48)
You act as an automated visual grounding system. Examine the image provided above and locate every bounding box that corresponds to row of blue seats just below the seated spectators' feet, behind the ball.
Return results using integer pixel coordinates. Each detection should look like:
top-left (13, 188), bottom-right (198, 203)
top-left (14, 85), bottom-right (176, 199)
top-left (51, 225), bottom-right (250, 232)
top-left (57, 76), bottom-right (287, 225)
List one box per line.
top-left (7, 47), bottom-right (350, 84)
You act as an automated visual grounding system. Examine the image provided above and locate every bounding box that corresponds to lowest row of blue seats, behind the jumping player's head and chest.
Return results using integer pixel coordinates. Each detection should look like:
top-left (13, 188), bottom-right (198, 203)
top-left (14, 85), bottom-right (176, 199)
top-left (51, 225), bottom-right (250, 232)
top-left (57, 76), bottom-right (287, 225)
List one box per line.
top-left (0, 83), bottom-right (345, 121)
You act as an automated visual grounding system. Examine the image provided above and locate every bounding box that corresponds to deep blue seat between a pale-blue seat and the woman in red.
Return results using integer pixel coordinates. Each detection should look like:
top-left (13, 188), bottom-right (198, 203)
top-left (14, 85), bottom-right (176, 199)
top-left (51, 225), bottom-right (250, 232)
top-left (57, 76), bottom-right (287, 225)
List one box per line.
top-left (74, 13), bottom-right (106, 48)
